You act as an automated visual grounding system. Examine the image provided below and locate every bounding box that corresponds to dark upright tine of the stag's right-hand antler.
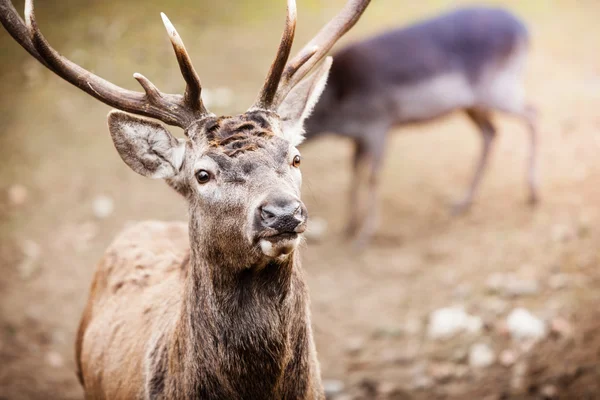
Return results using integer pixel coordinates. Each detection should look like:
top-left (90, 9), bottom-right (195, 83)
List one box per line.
top-left (254, 0), bottom-right (297, 109)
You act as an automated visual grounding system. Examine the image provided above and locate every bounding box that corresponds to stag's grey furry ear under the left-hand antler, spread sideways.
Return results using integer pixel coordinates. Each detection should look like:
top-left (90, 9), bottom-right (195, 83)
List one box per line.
top-left (108, 110), bottom-right (185, 179)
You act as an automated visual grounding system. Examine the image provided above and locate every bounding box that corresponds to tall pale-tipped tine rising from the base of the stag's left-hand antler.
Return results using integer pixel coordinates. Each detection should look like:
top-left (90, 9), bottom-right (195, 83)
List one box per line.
top-left (160, 13), bottom-right (208, 114)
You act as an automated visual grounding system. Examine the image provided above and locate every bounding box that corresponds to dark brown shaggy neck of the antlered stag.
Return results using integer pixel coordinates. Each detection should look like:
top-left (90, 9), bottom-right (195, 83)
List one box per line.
top-left (164, 227), bottom-right (312, 399)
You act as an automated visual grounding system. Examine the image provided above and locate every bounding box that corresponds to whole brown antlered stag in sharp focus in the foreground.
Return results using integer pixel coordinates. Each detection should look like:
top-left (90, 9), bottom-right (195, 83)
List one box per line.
top-left (0, 0), bottom-right (369, 399)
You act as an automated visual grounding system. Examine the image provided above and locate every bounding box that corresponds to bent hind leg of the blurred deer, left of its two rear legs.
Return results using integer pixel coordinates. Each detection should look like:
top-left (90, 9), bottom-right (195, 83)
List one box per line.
top-left (453, 109), bottom-right (496, 214)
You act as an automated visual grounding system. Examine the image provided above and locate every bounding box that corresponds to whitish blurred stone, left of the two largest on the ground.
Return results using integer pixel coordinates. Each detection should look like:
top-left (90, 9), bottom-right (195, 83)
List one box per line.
top-left (427, 307), bottom-right (483, 340)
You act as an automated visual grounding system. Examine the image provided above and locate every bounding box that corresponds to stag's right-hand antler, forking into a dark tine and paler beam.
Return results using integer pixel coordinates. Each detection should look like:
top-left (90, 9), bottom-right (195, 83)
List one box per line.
top-left (254, 0), bottom-right (371, 110)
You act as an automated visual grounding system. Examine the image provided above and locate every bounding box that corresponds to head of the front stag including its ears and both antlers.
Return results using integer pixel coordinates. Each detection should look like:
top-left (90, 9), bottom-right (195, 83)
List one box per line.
top-left (0, 0), bottom-right (369, 266)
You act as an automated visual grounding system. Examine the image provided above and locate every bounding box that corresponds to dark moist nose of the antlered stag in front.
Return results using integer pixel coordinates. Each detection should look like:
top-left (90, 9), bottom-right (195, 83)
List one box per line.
top-left (259, 196), bottom-right (307, 233)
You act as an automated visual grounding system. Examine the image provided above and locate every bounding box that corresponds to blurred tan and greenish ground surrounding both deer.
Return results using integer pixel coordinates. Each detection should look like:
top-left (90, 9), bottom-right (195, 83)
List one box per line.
top-left (0, 0), bottom-right (600, 400)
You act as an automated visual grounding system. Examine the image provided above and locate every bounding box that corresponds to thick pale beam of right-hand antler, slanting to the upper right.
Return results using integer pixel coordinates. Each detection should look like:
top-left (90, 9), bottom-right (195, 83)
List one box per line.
top-left (274, 0), bottom-right (371, 104)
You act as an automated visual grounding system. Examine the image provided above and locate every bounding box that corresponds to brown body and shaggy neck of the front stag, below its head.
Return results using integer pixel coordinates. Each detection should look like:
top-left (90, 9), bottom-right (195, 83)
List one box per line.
top-left (77, 221), bottom-right (322, 399)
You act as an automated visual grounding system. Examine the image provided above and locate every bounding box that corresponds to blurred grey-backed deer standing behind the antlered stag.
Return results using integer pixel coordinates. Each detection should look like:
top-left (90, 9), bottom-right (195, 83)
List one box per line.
top-left (305, 7), bottom-right (539, 248)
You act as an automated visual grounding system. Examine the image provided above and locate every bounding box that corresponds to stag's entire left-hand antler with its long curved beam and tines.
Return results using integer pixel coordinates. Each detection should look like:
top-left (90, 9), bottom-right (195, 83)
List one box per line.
top-left (0, 0), bottom-right (208, 128)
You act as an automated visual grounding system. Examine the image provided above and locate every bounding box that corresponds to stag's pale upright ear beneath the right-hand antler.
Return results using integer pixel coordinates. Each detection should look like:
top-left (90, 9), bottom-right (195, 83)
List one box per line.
top-left (277, 57), bottom-right (333, 146)
